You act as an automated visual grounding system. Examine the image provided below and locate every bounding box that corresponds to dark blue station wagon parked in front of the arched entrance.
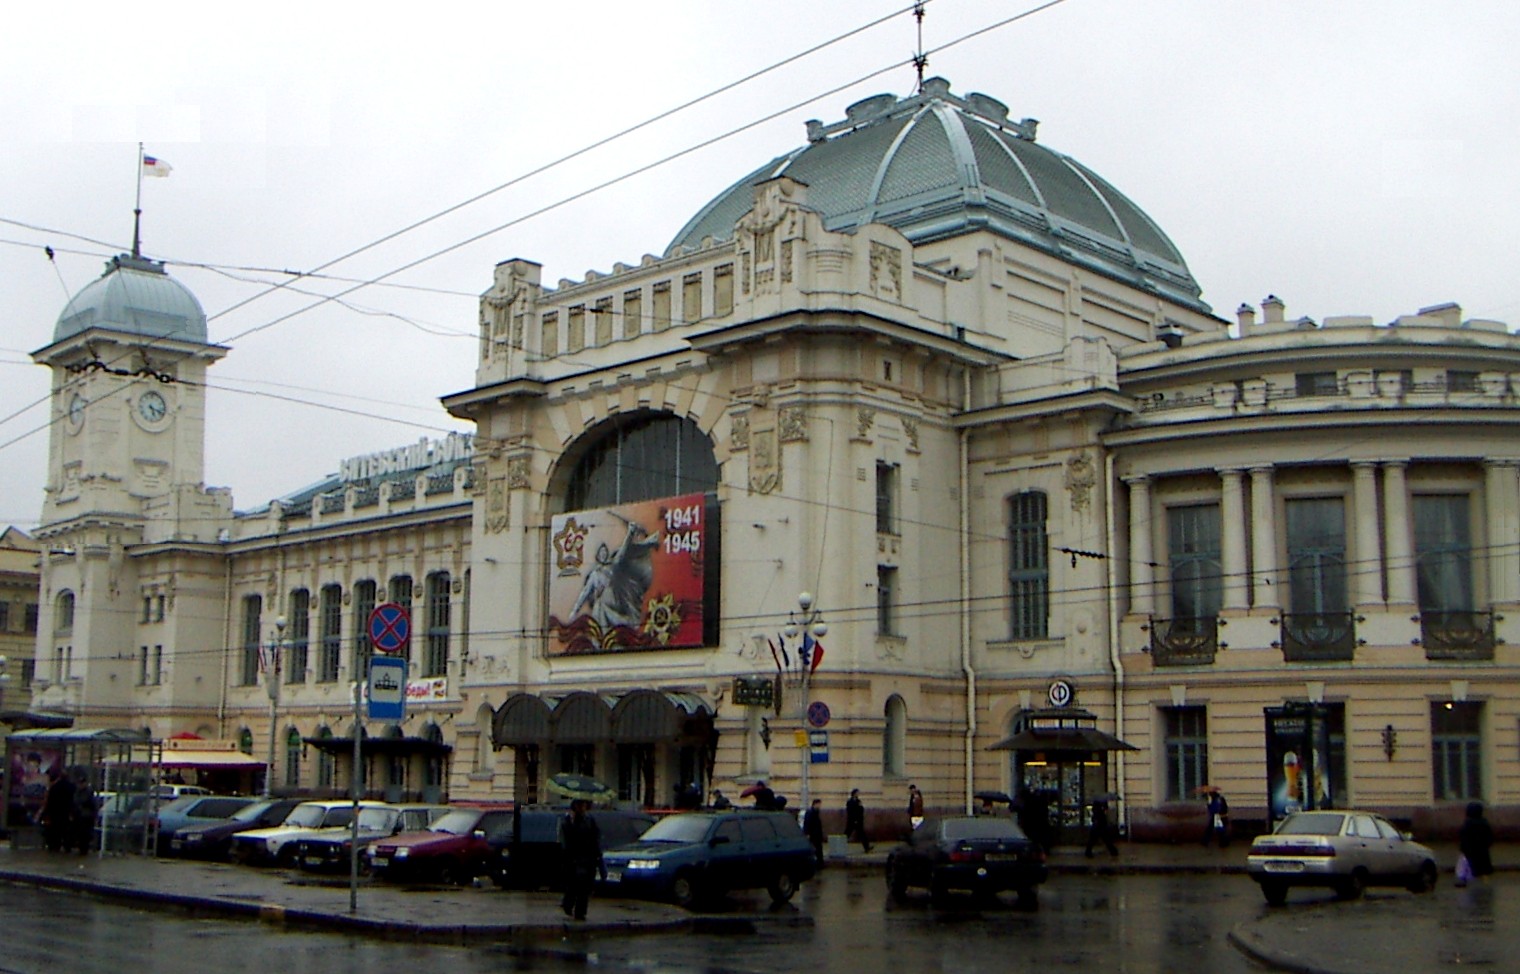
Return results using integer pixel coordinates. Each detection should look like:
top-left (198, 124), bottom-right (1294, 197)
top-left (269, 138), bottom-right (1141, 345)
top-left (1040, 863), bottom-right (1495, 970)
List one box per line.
top-left (602, 808), bottom-right (816, 907)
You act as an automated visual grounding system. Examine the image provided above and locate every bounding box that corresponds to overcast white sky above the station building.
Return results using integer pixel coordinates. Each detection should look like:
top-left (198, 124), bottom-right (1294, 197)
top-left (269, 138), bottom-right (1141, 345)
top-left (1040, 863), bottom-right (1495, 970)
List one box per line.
top-left (0, 0), bottom-right (1520, 530)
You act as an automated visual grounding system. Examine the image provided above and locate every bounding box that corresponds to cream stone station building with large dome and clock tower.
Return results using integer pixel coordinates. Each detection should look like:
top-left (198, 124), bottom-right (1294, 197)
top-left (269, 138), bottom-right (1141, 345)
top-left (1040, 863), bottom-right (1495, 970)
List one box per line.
top-left (32, 79), bottom-right (1520, 836)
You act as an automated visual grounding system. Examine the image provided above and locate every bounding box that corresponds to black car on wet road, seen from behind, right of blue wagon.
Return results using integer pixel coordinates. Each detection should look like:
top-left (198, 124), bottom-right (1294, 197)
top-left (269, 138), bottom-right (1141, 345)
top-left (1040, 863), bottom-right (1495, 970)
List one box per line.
top-left (886, 816), bottom-right (1050, 909)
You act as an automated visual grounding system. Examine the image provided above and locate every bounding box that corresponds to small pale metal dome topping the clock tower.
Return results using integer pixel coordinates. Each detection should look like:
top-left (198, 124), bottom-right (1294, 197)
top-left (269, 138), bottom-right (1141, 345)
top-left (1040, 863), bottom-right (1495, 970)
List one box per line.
top-left (53, 254), bottom-right (207, 343)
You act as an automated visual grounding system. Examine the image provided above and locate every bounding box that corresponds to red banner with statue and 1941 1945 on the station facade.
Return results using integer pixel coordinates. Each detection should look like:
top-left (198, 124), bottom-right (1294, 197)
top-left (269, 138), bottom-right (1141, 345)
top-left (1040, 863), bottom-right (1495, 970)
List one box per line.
top-left (549, 494), bottom-right (708, 655)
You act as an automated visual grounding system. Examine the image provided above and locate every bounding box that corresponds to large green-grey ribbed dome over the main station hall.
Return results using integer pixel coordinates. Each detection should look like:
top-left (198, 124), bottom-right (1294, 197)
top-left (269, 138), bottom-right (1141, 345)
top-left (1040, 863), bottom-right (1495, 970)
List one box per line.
top-left (666, 77), bottom-right (1208, 311)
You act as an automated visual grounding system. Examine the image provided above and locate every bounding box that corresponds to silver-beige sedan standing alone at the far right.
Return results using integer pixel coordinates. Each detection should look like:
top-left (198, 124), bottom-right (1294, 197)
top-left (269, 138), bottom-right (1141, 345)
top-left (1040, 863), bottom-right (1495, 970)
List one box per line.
top-left (1245, 810), bottom-right (1438, 906)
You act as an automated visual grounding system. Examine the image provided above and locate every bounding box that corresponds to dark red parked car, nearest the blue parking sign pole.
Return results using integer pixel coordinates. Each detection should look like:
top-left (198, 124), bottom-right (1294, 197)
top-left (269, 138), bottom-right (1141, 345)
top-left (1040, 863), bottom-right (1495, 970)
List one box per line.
top-left (369, 807), bottom-right (512, 884)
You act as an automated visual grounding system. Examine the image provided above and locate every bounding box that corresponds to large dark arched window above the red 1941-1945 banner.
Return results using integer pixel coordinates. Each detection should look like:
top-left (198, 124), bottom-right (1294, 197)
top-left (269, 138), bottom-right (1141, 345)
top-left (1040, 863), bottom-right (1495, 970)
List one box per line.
top-left (565, 412), bottom-right (717, 511)
